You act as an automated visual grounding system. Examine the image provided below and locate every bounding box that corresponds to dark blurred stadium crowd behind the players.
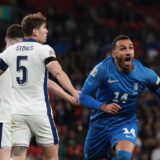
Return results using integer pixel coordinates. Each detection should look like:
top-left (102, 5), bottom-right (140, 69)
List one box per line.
top-left (0, 0), bottom-right (160, 160)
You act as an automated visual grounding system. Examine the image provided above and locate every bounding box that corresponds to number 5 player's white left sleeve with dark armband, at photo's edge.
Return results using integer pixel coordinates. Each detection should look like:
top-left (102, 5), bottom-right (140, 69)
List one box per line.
top-left (0, 51), bottom-right (8, 71)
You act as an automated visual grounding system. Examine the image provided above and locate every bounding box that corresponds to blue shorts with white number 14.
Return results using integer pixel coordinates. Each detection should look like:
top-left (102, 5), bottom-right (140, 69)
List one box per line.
top-left (84, 122), bottom-right (138, 160)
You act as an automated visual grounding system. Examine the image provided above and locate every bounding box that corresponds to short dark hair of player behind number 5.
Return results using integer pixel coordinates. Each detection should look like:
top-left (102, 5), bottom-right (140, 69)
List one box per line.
top-left (6, 24), bottom-right (24, 38)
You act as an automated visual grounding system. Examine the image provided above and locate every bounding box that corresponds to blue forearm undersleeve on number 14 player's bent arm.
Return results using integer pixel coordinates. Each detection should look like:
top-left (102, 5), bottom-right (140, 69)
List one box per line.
top-left (80, 92), bottom-right (103, 110)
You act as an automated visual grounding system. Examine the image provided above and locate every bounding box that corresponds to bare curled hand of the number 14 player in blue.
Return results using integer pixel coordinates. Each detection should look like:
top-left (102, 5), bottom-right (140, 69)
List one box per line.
top-left (100, 103), bottom-right (121, 114)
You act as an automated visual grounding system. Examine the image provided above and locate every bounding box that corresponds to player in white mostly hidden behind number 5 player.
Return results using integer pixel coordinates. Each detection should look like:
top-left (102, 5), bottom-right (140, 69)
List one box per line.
top-left (0, 24), bottom-right (24, 160)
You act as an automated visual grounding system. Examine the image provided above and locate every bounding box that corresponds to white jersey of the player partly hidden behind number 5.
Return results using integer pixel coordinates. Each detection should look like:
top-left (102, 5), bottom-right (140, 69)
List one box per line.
top-left (0, 69), bottom-right (14, 123)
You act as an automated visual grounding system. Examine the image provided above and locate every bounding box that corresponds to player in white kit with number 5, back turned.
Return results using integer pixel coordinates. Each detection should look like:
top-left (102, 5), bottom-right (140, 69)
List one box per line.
top-left (0, 13), bottom-right (79, 160)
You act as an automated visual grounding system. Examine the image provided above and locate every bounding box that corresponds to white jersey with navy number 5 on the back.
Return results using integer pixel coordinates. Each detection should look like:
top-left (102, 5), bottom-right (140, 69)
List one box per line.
top-left (1, 41), bottom-right (56, 115)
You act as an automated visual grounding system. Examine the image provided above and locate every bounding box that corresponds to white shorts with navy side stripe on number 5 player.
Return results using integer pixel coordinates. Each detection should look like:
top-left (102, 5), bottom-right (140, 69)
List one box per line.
top-left (12, 115), bottom-right (59, 147)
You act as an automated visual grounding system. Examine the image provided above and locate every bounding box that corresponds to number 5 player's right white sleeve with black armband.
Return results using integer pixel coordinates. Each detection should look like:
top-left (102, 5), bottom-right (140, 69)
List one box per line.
top-left (40, 45), bottom-right (57, 65)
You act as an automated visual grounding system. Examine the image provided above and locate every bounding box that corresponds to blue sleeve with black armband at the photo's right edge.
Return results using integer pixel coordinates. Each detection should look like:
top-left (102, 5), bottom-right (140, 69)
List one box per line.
top-left (147, 68), bottom-right (160, 97)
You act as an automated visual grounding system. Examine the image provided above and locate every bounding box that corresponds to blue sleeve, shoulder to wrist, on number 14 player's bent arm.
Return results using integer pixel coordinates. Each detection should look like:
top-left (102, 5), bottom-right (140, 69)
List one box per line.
top-left (80, 64), bottom-right (105, 109)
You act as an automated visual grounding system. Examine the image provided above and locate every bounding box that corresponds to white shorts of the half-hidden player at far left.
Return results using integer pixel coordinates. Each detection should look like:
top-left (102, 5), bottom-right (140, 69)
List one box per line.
top-left (0, 122), bottom-right (11, 149)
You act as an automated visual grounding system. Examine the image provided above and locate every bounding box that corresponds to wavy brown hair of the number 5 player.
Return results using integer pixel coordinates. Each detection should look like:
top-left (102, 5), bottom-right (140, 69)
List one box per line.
top-left (21, 12), bottom-right (46, 36)
